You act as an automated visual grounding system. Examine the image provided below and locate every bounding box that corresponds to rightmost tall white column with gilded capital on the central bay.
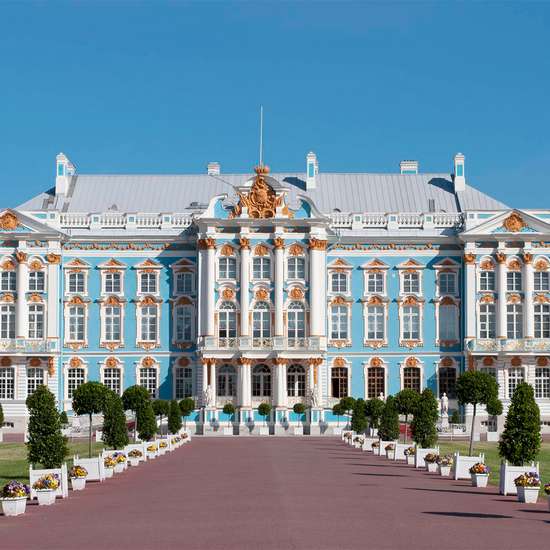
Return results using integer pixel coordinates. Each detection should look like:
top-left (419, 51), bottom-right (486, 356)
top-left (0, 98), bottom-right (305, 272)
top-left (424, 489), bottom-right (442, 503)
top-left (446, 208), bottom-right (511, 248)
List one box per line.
top-left (309, 238), bottom-right (327, 336)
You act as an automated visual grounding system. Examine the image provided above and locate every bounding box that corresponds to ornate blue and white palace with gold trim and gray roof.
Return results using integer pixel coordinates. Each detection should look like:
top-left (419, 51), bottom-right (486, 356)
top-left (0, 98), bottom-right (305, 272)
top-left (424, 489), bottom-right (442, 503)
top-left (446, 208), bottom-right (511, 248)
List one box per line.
top-left (0, 153), bottom-right (550, 434)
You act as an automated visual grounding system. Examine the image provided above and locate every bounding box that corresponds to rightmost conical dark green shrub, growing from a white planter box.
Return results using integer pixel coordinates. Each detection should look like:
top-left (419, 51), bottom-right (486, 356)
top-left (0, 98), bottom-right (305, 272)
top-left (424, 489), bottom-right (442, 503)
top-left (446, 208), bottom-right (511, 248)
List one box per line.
top-left (498, 382), bottom-right (541, 466)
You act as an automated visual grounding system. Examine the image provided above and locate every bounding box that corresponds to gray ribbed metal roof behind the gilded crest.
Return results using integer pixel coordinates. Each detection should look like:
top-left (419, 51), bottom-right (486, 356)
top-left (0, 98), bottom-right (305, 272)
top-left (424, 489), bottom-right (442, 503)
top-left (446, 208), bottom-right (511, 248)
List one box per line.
top-left (18, 173), bottom-right (507, 214)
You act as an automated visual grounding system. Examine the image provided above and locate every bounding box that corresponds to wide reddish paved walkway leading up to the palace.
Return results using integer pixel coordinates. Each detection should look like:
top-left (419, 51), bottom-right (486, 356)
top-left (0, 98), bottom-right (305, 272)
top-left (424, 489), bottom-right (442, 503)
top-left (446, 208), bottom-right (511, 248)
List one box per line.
top-left (0, 437), bottom-right (550, 550)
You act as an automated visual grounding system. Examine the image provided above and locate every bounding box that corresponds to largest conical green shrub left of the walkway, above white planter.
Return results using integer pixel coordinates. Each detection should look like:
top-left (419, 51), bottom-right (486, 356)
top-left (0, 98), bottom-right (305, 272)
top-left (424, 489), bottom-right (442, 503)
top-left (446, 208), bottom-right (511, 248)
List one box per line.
top-left (26, 386), bottom-right (69, 468)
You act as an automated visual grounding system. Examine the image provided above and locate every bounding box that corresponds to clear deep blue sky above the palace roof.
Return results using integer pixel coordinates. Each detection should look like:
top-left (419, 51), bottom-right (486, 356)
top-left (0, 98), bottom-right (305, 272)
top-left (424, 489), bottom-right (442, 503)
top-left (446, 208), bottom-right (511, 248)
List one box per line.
top-left (0, 0), bottom-right (550, 208)
